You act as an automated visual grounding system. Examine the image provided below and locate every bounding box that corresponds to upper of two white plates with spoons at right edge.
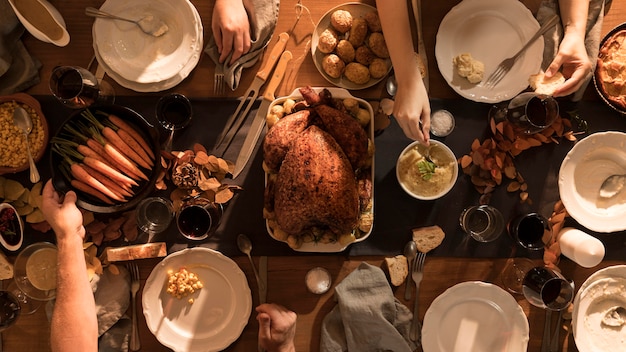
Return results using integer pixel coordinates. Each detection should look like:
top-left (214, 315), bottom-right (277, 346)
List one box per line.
top-left (559, 132), bottom-right (626, 232)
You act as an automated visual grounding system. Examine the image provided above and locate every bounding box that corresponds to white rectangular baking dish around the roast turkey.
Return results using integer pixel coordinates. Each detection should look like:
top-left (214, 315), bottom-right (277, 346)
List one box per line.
top-left (265, 87), bottom-right (375, 253)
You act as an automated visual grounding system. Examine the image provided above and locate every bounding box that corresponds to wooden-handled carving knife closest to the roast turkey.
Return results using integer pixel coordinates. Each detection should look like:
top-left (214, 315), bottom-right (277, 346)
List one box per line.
top-left (233, 50), bottom-right (293, 179)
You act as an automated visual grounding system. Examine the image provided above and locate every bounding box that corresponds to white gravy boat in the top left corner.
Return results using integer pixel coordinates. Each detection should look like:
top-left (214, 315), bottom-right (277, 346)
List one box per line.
top-left (9, 0), bottom-right (70, 47)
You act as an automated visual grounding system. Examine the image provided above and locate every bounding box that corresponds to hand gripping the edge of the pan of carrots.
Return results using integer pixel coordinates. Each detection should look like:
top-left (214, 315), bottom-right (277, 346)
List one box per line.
top-left (41, 180), bottom-right (85, 241)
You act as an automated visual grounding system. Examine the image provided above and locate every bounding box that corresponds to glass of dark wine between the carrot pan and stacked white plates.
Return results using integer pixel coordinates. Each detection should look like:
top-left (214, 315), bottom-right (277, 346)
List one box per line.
top-left (50, 66), bottom-right (115, 109)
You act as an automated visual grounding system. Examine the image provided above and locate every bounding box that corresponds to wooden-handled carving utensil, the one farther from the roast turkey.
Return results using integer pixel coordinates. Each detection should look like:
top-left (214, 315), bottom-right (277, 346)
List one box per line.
top-left (213, 32), bottom-right (289, 156)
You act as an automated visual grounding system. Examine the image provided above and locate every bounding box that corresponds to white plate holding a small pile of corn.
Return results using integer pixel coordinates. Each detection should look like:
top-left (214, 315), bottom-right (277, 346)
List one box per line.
top-left (142, 247), bottom-right (252, 352)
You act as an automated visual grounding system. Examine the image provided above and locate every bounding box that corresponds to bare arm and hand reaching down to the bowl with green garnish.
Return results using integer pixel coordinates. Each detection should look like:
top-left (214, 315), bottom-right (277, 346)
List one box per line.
top-left (376, 0), bottom-right (430, 144)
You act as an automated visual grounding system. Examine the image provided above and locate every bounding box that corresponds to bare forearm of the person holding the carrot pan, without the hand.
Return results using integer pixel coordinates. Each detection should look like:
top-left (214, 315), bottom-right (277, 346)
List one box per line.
top-left (51, 231), bottom-right (98, 351)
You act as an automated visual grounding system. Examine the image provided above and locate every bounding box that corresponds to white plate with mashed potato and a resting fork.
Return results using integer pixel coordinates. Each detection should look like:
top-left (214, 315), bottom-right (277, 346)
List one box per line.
top-left (435, 0), bottom-right (544, 103)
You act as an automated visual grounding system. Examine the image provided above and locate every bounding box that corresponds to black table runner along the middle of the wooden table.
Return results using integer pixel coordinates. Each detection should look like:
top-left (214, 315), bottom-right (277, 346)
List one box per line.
top-left (16, 95), bottom-right (626, 259)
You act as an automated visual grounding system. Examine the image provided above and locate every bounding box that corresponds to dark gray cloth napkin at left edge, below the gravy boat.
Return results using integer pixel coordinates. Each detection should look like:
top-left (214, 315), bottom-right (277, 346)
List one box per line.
top-left (0, 0), bottom-right (41, 95)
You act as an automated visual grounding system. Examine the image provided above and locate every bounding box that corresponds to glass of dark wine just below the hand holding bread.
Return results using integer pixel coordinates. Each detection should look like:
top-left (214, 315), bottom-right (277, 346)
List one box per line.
top-left (489, 92), bottom-right (559, 134)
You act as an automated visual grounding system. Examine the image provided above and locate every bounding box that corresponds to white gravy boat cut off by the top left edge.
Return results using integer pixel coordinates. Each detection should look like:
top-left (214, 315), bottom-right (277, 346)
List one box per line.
top-left (9, 0), bottom-right (70, 46)
